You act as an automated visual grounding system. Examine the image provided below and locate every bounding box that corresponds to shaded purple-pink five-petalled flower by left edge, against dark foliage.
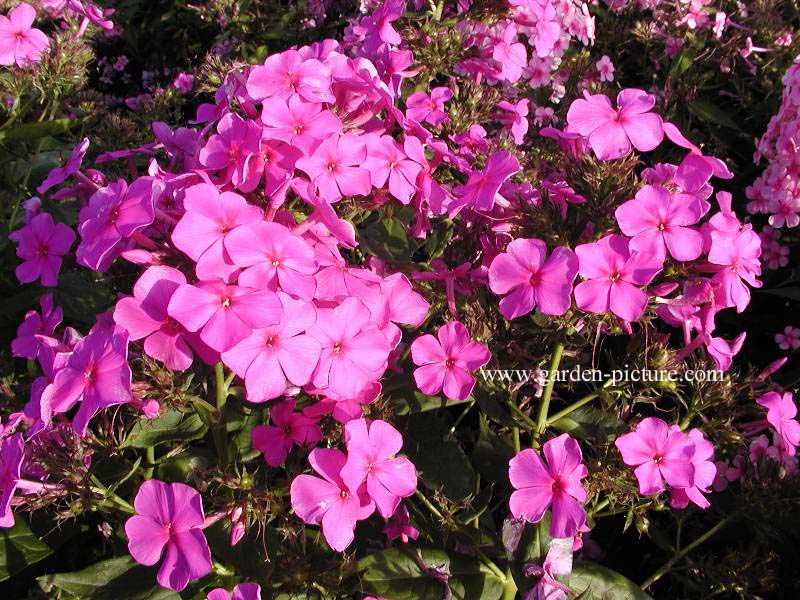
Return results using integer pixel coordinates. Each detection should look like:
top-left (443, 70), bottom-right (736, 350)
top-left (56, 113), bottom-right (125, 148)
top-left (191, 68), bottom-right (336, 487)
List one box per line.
top-left (15, 213), bottom-right (75, 287)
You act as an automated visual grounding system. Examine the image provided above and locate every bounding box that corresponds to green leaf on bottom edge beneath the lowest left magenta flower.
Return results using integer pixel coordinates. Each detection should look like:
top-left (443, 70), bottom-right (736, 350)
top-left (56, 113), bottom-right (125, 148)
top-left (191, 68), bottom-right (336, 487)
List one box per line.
top-left (37, 556), bottom-right (180, 600)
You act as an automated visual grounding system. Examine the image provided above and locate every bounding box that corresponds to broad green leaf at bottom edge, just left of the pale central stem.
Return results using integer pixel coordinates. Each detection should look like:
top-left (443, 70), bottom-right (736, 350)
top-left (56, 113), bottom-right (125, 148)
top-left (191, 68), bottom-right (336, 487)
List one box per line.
top-left (358, 546), bottom-right (503, 600)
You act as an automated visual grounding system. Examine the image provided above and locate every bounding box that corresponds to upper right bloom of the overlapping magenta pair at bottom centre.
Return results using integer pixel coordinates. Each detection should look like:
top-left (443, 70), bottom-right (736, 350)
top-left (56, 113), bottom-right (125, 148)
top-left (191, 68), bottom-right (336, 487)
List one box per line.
top-left (341, 419), bottom-right (417, 519)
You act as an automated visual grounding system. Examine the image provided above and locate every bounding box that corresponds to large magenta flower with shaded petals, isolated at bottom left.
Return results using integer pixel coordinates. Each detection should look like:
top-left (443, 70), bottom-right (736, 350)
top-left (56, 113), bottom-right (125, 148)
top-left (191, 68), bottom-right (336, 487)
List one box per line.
top-left (125, 479), bottom-right (211, 592)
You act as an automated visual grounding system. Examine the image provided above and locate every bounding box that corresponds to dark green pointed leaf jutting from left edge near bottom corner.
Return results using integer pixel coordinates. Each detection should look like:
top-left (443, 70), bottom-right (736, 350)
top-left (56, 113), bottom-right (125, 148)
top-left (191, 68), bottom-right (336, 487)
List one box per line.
top-left (0, 517), bottom-right (76, 581)
